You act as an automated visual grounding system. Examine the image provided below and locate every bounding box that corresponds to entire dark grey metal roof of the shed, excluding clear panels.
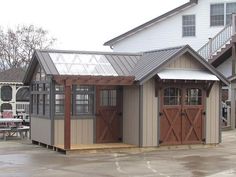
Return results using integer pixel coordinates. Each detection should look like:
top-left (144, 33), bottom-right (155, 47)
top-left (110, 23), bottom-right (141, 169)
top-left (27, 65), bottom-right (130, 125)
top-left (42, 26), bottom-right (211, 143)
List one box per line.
top-left (24, 45), bottom-right (229, 85)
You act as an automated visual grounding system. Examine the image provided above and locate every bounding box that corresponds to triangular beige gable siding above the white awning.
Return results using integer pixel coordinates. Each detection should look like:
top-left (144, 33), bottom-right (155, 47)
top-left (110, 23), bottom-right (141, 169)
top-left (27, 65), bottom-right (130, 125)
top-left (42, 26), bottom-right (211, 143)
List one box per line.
top-left (167, 54), bottom-right (204, 69)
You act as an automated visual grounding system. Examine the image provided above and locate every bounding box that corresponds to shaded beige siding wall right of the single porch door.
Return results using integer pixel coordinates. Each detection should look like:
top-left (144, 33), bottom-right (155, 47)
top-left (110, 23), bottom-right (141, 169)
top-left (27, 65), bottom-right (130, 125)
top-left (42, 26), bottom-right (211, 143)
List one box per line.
top-left (123, 86), bottom-right (139, 146)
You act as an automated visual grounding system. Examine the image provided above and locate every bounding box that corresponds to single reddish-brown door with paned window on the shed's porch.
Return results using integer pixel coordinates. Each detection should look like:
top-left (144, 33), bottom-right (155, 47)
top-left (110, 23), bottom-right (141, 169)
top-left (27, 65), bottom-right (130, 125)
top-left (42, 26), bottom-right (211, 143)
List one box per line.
top-left (96, 86), bottom-right (122, 143)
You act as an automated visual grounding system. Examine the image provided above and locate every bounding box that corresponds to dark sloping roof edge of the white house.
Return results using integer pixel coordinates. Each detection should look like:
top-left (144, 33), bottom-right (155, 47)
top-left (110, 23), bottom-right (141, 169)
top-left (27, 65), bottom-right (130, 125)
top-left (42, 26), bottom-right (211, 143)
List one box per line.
top-left (103, 0), bottom-right (198, 46)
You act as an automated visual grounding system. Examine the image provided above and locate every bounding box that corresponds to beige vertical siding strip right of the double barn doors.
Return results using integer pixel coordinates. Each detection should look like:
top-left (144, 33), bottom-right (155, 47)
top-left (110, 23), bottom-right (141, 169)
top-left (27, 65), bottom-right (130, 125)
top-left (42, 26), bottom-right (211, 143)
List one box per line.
top-left (206, 82), bottom-right (220, 144)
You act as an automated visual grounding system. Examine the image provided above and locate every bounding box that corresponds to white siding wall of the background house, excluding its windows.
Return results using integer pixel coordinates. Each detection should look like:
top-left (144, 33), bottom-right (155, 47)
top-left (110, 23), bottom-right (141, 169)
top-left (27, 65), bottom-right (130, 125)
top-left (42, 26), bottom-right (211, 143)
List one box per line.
top-left (113, 0), bottom-right (236, 52)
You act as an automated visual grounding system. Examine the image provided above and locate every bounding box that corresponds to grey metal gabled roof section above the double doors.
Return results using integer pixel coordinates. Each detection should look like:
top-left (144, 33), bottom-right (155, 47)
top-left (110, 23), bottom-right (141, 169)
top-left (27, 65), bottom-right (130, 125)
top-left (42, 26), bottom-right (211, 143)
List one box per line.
top-left (131, 45), bottom-right (229, 85)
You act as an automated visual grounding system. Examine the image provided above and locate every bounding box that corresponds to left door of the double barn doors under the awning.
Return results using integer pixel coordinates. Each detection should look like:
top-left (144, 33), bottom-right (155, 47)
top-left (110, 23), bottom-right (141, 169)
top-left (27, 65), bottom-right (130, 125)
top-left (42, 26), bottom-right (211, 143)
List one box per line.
top-left (160, 87), bottom-right (181, 145)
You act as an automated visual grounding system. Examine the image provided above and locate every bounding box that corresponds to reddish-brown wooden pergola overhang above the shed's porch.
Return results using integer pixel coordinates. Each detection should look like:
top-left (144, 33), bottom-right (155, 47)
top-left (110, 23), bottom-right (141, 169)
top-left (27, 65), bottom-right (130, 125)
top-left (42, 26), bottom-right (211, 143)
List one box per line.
top-left (53, 75), bottom-right (135, 85)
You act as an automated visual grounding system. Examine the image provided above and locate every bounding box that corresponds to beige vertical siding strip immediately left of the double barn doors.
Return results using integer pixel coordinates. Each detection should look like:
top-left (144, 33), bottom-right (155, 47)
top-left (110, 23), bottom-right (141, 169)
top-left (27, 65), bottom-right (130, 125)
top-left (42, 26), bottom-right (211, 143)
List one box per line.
top-left (142, 79), bottom-right (158, 147)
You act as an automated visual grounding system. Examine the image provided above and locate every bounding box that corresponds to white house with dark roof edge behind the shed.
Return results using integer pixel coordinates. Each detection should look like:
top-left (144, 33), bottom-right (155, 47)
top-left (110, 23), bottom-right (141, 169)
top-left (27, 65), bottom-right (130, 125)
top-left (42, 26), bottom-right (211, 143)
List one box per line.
top-left (104, 0), bottom-right (236, 52)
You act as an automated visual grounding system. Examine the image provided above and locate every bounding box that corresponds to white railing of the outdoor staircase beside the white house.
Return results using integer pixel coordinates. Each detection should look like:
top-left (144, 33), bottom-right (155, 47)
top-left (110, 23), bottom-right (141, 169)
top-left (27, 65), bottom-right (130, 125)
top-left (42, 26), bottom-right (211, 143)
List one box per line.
top-left (198, 14), bottom-right (236, 60)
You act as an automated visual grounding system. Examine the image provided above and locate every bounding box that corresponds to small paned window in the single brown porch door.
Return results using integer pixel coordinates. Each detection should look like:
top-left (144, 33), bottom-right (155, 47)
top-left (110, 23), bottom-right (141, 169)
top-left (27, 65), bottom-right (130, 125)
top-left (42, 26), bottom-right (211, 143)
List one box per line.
top-left (100, 90), bottom-right (117, 106)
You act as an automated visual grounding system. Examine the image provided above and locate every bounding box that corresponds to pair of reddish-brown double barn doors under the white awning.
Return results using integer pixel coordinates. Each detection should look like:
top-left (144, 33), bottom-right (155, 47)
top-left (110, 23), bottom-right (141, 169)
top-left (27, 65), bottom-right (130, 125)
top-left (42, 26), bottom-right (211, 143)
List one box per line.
top-left (159, 86), bottom-right (205, 145)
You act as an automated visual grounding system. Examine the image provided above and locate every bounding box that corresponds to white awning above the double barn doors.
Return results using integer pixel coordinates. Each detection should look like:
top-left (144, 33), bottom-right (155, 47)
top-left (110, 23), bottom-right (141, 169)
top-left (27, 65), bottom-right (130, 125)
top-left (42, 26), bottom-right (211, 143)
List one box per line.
top-left (157, 69), bottom-right (219, 81)
